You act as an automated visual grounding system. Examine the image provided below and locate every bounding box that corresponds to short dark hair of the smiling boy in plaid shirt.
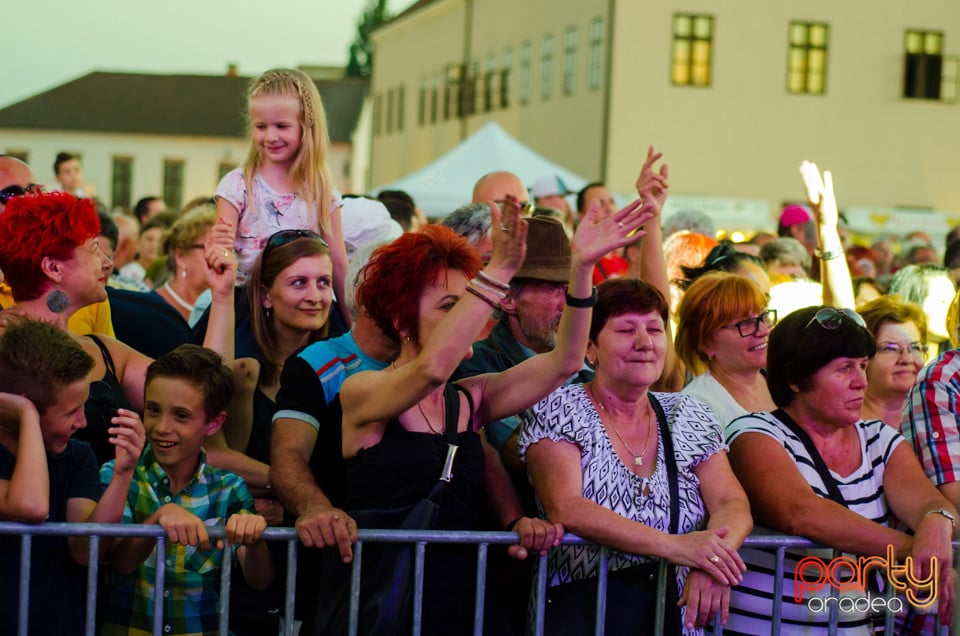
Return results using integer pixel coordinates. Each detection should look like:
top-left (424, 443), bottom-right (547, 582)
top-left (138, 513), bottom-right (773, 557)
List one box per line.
top-left (145, 344), bottom-right (234, 420)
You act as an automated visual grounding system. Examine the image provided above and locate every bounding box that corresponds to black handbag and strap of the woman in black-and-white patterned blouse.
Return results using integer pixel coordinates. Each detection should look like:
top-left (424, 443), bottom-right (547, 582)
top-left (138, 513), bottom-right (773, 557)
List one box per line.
top-left (544, 394), bottom-right (682, 635)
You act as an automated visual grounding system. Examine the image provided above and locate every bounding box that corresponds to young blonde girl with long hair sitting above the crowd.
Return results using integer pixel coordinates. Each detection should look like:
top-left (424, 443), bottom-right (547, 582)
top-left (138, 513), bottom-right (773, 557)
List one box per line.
top-left (216, 69), bottom-right (351, 326)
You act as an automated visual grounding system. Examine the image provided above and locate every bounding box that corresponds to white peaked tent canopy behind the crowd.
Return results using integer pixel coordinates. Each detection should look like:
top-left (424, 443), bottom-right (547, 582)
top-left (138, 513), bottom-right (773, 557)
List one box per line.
top-left (373, 122), bottom-right (587, 217)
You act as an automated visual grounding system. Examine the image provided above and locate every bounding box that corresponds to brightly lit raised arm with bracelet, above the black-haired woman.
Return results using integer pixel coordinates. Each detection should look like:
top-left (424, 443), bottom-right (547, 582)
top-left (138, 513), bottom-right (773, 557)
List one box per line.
top-left (800, 161), bottom-right (856, 309)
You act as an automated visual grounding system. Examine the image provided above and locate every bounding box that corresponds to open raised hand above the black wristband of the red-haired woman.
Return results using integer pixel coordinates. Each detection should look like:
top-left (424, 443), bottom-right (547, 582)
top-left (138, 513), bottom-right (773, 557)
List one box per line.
top-left (571, 199), bottom-right (657, 268)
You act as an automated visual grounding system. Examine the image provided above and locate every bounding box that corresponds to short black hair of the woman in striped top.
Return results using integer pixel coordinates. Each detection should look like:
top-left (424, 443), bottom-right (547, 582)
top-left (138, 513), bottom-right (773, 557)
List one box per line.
top-left (767, 305), bottom-right (877, 407)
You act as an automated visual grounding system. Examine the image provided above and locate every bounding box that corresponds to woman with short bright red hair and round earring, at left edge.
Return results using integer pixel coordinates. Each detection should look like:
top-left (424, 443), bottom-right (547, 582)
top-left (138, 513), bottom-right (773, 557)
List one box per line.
top-left (0, 192), bottom-right (236, 463)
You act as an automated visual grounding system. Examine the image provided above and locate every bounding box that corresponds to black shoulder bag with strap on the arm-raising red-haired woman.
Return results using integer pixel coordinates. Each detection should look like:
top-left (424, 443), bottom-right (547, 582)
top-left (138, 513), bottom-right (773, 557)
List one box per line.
top-left (301, 384), bottom-right (469, 636)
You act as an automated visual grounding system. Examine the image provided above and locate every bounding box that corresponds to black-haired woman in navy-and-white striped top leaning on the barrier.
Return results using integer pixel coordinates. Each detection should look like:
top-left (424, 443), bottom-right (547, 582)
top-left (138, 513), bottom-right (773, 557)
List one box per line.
top-left (725, 306), bottom-right (958, 634)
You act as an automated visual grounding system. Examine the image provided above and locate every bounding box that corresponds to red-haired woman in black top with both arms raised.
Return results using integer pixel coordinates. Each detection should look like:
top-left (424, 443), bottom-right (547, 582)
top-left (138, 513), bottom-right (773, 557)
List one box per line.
top-left (340, 201), bottom-right (650, 634)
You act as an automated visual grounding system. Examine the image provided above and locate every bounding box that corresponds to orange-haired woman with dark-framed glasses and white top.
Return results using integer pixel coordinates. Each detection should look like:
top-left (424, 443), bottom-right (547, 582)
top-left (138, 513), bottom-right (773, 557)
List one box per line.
top-left (675, 272), bottom-right (777, 426)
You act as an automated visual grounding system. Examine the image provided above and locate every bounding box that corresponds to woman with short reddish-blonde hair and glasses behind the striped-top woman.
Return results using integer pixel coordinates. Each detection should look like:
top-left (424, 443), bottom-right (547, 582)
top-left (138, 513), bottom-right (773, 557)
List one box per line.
top-left (859, 296), bottom-right (927, 431)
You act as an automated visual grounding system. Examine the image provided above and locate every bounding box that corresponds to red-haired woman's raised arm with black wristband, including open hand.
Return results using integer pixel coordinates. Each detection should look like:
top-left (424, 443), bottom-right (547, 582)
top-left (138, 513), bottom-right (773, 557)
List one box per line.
top-left (460, 200), bottom-right (652, 424)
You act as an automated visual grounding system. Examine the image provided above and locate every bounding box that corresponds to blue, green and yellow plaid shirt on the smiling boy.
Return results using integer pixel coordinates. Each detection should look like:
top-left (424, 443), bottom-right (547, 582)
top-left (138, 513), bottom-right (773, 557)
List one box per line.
top-left (100, 446), bottom-right (254, 636)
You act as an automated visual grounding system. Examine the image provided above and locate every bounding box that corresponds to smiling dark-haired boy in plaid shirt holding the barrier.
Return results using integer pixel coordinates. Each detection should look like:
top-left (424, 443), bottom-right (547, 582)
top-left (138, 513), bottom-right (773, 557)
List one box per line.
top-left (100, 345), bottom-right (273, 635)
